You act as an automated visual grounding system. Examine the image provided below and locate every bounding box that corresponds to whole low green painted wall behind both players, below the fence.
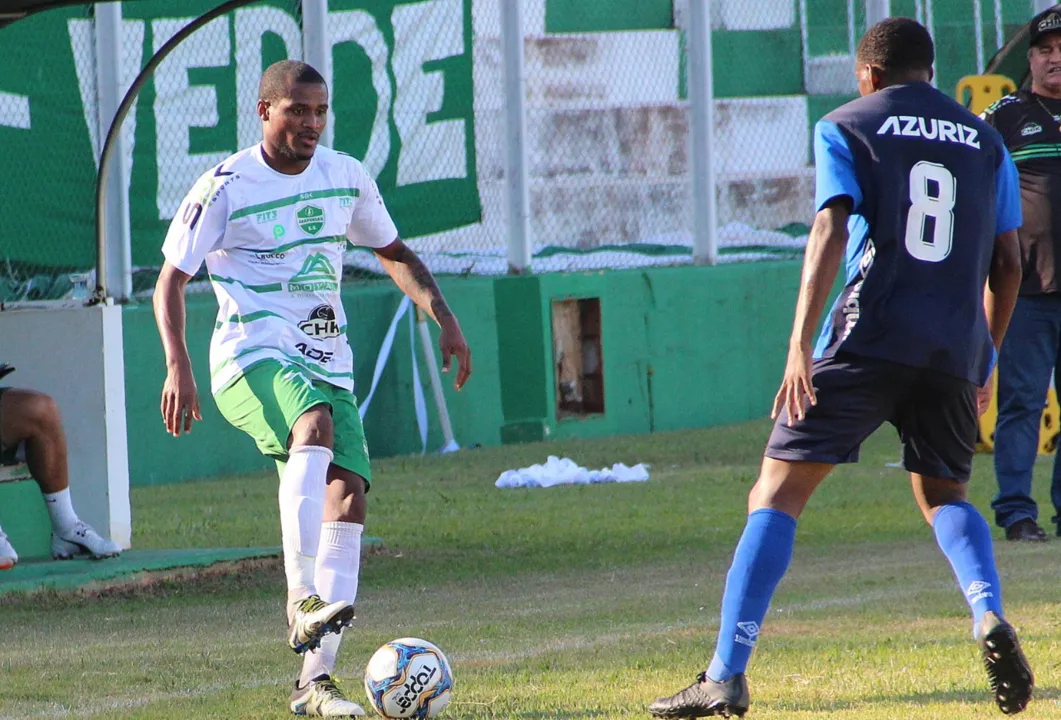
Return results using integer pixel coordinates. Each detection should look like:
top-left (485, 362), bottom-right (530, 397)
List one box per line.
top-left (124, 261), bottom-right (800, 486)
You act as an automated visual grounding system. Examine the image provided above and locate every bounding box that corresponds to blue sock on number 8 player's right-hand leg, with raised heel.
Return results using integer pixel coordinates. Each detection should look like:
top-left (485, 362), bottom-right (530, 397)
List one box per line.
top-left (933, 503), bottom-right (1003, 634)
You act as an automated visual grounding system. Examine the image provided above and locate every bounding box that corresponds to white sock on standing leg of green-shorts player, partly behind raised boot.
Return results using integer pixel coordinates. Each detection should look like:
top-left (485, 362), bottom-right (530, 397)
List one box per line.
top-left (301, 523), bottom-right (365, 686)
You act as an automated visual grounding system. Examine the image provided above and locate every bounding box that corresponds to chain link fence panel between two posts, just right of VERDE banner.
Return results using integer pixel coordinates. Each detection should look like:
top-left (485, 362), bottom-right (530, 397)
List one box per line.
top-left (523, 0), bottom-right (692, 271)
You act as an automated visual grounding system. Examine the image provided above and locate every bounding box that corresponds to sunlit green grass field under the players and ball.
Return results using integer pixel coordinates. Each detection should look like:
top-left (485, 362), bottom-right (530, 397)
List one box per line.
top-left (0, 423), bottom-right (1061, 720)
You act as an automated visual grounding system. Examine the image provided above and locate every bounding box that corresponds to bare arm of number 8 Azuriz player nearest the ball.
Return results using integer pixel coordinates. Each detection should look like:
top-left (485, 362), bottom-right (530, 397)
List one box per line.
top-left (770, 196), bottom-right (851, 424)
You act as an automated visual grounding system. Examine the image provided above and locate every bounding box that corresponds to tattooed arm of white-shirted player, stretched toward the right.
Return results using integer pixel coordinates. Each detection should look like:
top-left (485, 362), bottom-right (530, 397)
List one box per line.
top-left (375, 239), bottom-right (471, 390)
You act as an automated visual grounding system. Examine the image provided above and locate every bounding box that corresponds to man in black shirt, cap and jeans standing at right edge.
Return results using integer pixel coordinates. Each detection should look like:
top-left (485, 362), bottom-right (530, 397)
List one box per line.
top-left (982, 8), bottom-right (1061, 541)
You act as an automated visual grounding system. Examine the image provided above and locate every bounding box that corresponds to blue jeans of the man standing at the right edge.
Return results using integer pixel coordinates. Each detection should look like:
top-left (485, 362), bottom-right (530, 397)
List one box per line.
top-left (991, 295), bottom-right (1061, 527)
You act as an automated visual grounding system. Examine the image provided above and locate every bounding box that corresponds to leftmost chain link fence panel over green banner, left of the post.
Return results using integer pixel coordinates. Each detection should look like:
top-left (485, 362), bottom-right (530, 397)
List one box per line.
top-left (0, 6), bottom-right (97, 301)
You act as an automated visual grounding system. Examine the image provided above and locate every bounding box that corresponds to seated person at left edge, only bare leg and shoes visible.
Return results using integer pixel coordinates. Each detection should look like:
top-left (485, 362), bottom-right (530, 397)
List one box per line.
top-left (0, 365), bottom-right (122, 570)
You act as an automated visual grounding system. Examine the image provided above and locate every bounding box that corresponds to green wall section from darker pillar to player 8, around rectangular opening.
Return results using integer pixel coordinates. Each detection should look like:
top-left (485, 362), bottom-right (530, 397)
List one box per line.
top-left (494, 262), bottom-right (799, 441)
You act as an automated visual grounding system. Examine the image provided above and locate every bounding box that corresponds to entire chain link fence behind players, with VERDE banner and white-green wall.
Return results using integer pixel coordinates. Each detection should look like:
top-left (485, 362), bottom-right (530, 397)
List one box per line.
top-left (0, 0), bottom-right (1034, 300)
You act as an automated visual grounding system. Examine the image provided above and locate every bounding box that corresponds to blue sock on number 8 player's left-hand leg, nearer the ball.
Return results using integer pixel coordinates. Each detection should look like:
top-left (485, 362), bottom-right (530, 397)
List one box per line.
top-left (708, 509), bottom-right (796, 683)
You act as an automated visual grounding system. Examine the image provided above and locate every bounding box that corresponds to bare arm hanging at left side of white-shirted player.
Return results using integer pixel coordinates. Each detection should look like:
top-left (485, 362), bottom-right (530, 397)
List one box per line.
top-left (153, 262), bottom-right (203, 437)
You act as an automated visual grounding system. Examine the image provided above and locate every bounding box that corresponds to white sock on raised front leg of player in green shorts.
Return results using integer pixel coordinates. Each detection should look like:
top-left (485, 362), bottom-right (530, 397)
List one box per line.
top-left (279, 445), bottom-right (332, 601)
